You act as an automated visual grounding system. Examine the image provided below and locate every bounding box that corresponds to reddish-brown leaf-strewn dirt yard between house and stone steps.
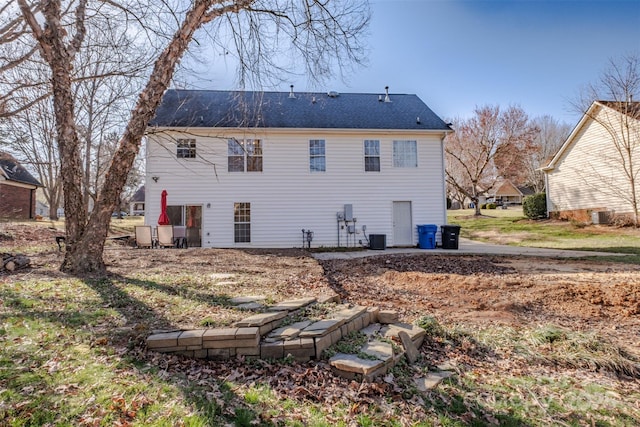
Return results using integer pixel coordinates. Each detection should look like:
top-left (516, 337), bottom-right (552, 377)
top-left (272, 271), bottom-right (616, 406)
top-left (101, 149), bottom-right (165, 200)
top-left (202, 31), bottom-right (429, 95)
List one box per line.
top-left (0, 224), bottom-right (640, 354)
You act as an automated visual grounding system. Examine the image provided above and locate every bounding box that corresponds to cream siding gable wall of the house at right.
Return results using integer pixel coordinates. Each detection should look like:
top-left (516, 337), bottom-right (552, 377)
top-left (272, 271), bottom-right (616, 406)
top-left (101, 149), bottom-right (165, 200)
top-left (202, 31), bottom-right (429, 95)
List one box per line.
top-left (548, 106), bottom-right (640, 213)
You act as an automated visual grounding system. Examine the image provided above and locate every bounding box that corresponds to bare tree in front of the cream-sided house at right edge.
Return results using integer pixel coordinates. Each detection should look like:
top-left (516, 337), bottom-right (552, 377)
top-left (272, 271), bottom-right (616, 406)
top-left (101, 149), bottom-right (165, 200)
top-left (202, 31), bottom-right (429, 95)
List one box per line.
top-left (572, 53), bottom-right (640, 227)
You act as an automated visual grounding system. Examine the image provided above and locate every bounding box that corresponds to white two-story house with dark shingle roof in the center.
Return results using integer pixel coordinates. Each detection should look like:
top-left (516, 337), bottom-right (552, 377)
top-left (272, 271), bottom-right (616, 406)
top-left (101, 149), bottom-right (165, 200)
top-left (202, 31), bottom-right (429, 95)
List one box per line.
top-left (145, 88), bottom-right (451, 247)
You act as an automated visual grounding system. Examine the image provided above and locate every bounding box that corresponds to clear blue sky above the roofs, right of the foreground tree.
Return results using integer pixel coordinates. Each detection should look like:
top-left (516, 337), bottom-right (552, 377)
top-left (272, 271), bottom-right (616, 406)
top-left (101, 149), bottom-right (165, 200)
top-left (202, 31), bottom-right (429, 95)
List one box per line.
top-left (190, 0), bottom-right (640, 125)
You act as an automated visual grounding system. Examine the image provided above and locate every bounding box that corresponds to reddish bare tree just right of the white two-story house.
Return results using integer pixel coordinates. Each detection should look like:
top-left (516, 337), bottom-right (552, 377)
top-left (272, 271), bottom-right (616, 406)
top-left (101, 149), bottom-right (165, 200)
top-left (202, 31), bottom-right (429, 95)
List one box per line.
top-left (445, 106), bottom-right (537, 215)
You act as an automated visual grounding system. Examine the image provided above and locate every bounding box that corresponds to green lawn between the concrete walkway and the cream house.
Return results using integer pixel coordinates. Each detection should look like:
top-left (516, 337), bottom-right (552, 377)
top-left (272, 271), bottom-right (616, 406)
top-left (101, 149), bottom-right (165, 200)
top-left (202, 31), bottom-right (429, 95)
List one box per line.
top-left (448, 206), bottom-right (640, 263)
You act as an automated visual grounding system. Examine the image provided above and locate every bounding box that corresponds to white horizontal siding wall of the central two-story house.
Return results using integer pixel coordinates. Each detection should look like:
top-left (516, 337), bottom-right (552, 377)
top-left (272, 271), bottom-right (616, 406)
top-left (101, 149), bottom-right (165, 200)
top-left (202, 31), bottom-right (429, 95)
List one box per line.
top-left (145, 130), bottom-right (446, 247)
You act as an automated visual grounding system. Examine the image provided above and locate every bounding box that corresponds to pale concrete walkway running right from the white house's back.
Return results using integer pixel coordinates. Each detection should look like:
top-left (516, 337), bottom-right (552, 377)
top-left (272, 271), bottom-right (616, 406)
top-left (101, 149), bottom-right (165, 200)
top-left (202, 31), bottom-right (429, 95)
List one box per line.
top-left (313, 238), bottom-right (629, 260)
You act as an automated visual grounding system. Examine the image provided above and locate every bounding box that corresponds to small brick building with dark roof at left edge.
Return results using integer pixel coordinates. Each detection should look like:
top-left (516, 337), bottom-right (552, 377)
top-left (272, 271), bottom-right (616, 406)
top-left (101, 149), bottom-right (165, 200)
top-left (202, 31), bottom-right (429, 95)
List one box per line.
top-left (0, 151), bottom-right (42, 219)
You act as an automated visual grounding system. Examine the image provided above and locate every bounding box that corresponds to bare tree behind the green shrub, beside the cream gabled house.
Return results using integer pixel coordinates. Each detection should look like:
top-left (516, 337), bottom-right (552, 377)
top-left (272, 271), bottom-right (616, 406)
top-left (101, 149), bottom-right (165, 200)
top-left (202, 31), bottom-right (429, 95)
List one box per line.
top-left (522, 116), bottom-right (571, 193)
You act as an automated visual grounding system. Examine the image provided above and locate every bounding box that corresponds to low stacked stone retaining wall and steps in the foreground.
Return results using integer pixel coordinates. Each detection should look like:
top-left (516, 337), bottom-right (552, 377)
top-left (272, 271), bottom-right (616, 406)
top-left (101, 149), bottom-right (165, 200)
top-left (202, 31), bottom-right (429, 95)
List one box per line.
top-left (147, 295), bottom-right (425, 380)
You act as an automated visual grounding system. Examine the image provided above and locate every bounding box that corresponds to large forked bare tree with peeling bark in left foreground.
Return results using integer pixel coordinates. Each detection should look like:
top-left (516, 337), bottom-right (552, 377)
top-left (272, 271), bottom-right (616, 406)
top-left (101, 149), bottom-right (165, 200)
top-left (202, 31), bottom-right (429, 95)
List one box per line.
top-left (0, 0), bottom-right (369, 274)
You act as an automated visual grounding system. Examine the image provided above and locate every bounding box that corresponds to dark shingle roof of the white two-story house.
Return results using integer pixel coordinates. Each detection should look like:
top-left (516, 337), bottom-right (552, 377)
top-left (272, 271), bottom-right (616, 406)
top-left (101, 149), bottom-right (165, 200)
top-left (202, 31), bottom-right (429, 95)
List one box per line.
top-left (149, 90), bottom-right (450, 131)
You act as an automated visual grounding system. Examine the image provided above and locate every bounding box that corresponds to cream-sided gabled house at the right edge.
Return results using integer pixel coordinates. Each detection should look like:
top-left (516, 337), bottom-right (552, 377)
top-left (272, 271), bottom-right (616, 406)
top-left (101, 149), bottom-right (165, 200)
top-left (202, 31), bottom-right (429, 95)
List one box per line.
top-left (542, 101), bottom-right (640, 221)
